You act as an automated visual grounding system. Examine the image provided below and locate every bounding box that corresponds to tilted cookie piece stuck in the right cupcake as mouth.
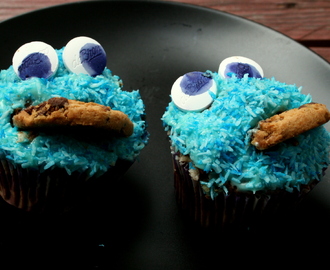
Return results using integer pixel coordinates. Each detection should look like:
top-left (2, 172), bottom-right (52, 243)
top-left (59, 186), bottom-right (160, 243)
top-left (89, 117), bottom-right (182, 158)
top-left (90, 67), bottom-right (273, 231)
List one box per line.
top-left (251, 103), bottom-right (330, 150)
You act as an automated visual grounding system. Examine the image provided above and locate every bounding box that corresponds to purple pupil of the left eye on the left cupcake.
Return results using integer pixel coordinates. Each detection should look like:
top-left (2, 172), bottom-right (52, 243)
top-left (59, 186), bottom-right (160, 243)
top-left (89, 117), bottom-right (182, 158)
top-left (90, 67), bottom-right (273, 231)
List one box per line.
top-left (18, 52), bottom-right (52, 80)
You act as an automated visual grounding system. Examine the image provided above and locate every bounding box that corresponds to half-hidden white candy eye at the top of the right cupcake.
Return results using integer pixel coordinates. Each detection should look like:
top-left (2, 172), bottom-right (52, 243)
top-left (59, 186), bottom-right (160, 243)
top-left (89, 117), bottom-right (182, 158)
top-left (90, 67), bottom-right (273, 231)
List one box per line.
top-left (218, 56), bottom-right (264, 78)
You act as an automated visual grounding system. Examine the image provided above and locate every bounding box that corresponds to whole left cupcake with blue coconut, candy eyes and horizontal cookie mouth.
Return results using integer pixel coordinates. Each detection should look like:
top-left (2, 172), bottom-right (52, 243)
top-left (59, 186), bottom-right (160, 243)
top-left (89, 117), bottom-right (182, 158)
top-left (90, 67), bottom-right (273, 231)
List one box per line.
top-left (0, 37), bottom-right (148, 212)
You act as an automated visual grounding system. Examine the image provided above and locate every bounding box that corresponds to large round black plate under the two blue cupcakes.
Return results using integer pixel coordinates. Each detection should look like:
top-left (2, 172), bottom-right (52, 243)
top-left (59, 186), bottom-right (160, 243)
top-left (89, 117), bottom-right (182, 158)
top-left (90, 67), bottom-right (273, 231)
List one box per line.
top-left (0, 1), bottom-right (330, 269)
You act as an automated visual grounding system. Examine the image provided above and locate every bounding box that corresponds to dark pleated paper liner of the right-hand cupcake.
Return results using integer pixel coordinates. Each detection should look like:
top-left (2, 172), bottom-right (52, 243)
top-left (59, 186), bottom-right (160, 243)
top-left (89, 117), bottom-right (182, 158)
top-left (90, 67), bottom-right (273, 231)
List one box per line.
top-left (173, 153), bottom-right (317, 230)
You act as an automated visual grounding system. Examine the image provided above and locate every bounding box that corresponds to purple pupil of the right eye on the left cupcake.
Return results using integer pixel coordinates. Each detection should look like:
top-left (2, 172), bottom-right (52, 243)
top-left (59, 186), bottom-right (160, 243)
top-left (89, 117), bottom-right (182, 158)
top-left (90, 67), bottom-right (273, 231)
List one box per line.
top-left (79, 43), bottom-right (107, 76)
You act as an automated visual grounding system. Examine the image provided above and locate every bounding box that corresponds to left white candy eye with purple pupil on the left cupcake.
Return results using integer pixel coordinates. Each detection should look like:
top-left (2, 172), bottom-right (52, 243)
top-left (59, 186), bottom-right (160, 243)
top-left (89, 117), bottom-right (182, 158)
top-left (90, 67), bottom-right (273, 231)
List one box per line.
top-left (13, 41), bottom-right (58, 80)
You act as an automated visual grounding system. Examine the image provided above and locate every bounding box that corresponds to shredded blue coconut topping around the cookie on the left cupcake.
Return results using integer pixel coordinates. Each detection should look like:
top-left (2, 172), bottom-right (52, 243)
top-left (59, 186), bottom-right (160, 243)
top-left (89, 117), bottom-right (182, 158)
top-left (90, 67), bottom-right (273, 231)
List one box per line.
top-left (0, 48), bottom-right (148, 179)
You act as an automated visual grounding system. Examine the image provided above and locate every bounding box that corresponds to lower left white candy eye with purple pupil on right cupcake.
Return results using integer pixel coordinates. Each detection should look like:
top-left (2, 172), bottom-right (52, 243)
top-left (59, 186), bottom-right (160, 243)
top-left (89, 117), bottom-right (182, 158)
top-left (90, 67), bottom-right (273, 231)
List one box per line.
top-left (171, 71), bottom-right (217, 111)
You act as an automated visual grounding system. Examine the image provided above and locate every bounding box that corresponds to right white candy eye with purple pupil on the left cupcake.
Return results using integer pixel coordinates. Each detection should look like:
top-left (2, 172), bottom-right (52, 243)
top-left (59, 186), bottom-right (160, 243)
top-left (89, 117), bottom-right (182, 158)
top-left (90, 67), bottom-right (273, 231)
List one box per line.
top-left (63, 37), bottom-right (107, 77)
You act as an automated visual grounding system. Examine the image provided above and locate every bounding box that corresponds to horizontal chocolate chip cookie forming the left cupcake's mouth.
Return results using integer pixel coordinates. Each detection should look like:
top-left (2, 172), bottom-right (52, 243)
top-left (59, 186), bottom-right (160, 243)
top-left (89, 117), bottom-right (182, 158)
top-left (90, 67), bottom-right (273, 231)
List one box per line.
top-left (13, 97), bottom-right (133, 137)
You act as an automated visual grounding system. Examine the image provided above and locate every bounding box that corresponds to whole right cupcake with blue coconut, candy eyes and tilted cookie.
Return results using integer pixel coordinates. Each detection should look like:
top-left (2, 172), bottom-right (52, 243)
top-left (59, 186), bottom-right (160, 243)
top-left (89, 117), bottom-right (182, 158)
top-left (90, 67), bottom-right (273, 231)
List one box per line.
top-left (162, 57), bottom-right (330, 230)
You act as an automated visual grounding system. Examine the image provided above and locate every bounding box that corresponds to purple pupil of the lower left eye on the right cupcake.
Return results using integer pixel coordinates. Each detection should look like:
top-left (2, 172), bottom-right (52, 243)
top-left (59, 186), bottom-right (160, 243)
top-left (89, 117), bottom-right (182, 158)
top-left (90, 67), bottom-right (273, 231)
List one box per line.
top-left (180, 71), bottom-right (213, 96)
